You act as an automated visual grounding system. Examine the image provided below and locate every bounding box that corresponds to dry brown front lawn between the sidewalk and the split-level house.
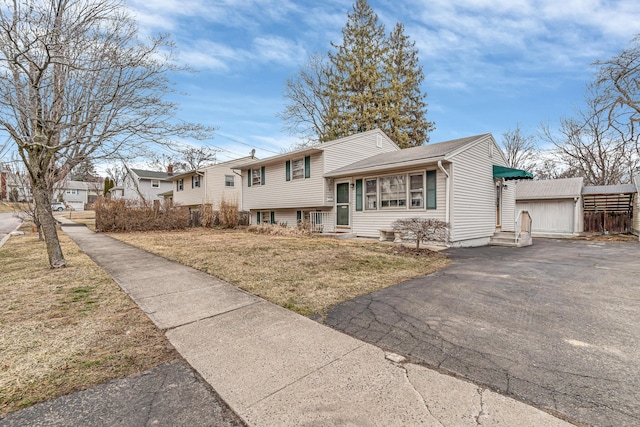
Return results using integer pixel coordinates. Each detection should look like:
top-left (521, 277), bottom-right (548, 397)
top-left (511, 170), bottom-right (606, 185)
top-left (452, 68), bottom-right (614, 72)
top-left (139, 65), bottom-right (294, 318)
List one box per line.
top-left (111, 228), bottom-right (449, 315)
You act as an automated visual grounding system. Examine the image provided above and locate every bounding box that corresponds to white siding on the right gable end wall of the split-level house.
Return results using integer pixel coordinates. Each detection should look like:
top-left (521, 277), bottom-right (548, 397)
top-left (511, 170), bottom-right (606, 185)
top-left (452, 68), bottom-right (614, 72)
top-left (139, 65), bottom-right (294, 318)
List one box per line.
top-left (448, 136), bottom-right (506, 245)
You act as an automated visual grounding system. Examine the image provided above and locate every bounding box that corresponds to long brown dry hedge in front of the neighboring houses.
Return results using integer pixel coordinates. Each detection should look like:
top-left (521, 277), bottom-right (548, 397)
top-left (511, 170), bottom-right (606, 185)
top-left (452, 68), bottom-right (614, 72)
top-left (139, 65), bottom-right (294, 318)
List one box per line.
top-left (95, 198), bottom-right (190, 232)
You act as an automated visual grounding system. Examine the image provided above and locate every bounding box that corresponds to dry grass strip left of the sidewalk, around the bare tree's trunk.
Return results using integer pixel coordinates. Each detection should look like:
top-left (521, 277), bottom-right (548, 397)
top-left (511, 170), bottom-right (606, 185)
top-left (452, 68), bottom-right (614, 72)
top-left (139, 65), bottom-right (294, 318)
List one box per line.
top-left (0, 224), bottom-right (178, 414)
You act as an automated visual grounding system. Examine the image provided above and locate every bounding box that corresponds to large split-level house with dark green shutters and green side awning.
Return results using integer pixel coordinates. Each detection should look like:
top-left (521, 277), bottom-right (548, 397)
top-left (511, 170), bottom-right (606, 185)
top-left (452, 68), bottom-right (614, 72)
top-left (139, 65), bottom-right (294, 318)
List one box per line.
top-left (240, 130), bottom-right (531, 246)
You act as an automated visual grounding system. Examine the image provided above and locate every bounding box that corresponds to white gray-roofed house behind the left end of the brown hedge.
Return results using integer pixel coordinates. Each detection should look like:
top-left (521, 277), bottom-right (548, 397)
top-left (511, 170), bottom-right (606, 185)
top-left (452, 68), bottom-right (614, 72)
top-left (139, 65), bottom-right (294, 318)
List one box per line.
top-left (109, 167), bottom-right (173, 203)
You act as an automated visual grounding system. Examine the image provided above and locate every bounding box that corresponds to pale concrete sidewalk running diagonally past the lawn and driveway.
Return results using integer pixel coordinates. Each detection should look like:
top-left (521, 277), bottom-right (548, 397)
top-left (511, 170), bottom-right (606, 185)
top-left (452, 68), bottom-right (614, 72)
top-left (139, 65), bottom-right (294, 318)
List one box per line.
top-left (63, 222), bottom-right (570, 426)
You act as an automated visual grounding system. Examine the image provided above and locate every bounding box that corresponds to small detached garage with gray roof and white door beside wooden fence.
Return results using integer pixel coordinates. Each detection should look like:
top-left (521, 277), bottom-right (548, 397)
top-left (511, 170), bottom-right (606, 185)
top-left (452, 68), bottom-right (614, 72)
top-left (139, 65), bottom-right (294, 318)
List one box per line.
top-left (516, 178), bottom-right (583, 237)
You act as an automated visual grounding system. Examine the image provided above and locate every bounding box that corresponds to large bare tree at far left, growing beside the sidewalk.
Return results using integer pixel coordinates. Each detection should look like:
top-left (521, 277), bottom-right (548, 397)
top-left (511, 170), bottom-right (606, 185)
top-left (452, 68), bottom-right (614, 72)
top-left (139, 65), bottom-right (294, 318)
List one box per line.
top-left (0, 0), bottom-right (215, 268)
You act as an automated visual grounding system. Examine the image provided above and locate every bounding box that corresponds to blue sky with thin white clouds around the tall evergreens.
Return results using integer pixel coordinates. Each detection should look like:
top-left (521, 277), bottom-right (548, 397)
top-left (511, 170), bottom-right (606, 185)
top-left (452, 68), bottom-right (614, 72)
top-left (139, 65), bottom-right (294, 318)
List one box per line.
top-left (128, 0), bottom-right (640, 161)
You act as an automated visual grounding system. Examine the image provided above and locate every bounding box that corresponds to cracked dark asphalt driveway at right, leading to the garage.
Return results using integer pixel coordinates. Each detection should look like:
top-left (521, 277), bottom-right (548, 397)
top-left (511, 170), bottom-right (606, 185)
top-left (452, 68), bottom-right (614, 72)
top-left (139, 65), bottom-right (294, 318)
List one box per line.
top-left (325, 239), bottom-right (640, 426)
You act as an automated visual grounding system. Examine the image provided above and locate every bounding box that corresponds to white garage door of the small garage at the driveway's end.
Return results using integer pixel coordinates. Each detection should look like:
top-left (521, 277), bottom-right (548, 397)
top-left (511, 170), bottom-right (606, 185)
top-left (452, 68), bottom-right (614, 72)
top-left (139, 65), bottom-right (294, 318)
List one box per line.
top-left (516, 200), bottom-right (575, 234)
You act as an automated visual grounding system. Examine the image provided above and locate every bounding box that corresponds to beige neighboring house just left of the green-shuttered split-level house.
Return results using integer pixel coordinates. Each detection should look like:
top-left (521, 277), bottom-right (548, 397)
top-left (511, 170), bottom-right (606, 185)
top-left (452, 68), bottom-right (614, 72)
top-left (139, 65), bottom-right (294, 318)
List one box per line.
top-left (170, 156), bottom-right (255, 210)
